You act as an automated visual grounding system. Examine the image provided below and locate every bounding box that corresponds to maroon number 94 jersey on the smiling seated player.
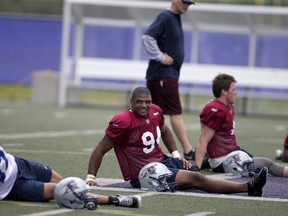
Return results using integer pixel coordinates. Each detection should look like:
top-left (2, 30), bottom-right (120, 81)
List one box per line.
top-left (105, 104), bottom-right (164, 181)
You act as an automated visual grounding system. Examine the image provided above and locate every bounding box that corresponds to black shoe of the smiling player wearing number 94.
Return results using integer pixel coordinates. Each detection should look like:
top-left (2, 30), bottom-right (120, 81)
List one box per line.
top-left (247, 167), bottom-right (268, 196)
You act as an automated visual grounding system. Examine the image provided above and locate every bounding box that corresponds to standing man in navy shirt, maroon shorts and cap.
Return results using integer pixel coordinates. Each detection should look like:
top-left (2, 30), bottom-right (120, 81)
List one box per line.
top-left (142, 0), bottom-right (200, 164)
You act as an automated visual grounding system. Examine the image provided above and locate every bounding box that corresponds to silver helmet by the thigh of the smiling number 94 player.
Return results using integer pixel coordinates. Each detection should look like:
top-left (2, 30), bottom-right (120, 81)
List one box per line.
top-left (138, 162), bottom-right (178, 192)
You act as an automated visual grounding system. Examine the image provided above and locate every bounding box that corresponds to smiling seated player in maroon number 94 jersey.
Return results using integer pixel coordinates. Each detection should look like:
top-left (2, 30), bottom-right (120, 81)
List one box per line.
top-left (86, 87), bottom-right (267, 196)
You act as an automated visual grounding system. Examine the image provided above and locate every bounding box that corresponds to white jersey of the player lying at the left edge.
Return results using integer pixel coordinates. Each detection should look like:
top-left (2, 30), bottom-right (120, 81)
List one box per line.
top-left (0, 146), bottom-right (18, 200)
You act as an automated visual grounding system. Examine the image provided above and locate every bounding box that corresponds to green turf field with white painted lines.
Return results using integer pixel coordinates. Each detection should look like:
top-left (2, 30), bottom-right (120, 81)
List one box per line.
top-left (0, 86), bottom-right (288, 216)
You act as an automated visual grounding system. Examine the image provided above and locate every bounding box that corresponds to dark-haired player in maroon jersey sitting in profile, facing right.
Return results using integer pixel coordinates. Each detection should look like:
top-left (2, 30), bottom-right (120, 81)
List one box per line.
top-left (194, 74), bottom-right (288, 177)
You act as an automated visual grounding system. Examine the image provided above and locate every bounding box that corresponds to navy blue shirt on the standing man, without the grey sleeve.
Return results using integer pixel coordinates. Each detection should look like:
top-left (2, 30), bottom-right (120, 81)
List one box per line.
top-left (144, 10), bottom-right (184, 80)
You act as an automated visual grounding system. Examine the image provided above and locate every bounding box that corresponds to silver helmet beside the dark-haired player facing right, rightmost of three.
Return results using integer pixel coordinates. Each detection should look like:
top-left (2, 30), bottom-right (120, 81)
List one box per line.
top-left (223, 150), bottom-right (255, 177)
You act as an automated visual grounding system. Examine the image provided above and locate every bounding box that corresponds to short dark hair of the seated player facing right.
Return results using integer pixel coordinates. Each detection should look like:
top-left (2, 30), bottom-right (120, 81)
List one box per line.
top-left (212, 73), bottom-right (237, 98)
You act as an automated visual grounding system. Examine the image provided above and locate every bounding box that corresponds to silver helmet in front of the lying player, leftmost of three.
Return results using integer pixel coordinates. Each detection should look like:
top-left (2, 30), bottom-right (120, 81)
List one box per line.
top-left (54, 177), bottom-right (97, 210)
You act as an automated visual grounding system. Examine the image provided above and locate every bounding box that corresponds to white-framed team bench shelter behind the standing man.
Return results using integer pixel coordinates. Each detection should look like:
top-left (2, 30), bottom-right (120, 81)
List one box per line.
top-left (58, 0), bottom-right (288, 114)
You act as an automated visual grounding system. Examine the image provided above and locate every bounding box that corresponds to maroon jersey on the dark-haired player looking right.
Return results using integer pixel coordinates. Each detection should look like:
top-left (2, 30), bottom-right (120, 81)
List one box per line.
top-left (200, 99), bottom-right (237, 158)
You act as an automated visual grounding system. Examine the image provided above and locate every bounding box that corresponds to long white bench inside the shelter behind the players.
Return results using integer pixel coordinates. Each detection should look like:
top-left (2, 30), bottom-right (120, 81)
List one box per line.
top-left (68, 58), bottom-right (288, 114)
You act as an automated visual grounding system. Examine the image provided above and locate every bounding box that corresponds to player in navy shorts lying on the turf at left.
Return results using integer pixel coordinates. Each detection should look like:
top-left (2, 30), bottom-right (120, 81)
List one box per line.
top-left (0, 146), bottom-right (141, 208)
